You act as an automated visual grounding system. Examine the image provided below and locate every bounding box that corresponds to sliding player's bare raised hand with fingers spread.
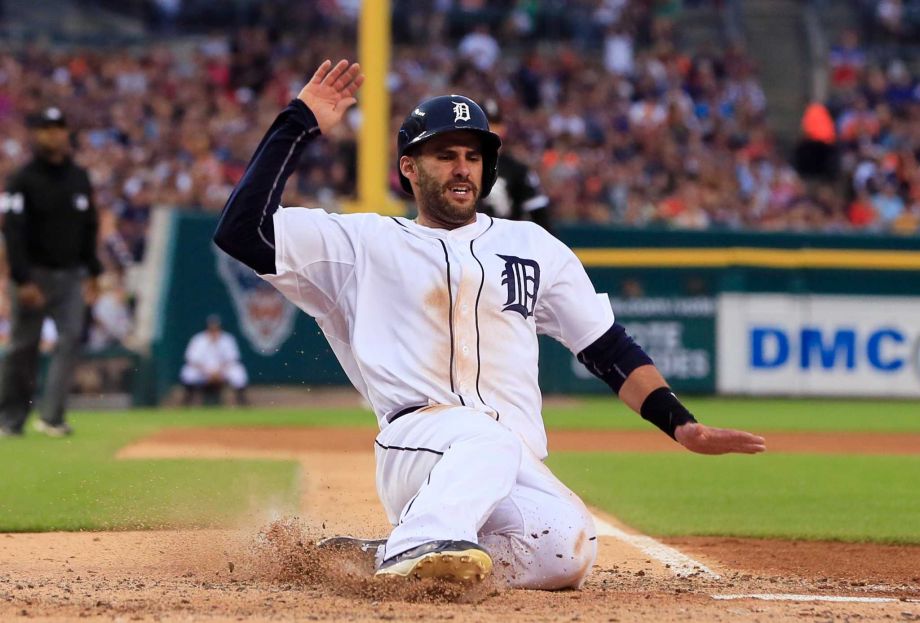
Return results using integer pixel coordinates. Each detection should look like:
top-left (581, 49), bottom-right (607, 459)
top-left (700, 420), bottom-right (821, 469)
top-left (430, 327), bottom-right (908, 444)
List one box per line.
top-left (297, 59), bottom-right (364, 134)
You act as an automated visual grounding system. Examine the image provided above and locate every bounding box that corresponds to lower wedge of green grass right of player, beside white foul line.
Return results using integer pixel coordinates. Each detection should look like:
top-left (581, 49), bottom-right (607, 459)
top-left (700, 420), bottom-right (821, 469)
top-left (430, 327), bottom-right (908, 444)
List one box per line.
top-left (547, 452), bottom-right (920, 543)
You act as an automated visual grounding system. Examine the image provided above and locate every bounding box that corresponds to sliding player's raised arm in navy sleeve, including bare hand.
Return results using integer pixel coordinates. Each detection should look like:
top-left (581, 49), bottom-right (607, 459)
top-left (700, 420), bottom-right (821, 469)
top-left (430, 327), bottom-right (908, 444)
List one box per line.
top-left (214, 60), bottom-right (364, 275)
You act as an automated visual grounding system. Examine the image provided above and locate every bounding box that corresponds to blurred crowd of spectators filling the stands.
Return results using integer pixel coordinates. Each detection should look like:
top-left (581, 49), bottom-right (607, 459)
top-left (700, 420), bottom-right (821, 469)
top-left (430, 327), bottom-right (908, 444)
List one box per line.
top-left (0, 0), bottom-right (920, 354)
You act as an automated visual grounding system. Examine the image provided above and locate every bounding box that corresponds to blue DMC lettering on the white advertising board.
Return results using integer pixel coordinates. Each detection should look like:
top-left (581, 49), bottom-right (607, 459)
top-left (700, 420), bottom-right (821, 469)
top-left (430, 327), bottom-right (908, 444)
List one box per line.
top-left (749, 326), bottom-right (911, 372)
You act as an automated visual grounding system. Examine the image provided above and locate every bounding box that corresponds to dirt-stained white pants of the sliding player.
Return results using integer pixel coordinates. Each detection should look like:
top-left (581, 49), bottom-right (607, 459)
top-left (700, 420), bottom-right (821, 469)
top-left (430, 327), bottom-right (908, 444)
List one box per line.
top-left (375, 406), bottom-right (597, 589)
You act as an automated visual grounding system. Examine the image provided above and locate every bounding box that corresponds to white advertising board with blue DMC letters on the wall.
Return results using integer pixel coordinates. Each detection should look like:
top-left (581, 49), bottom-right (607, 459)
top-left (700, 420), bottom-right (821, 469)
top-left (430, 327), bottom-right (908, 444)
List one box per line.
top-left (716, 294), bottom-right (920, 397)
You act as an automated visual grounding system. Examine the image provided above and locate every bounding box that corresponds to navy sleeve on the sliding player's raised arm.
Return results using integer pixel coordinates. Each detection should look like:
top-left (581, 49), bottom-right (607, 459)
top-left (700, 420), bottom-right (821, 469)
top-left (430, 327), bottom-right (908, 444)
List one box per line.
top-left (214, 99), bottom-right (320, 275)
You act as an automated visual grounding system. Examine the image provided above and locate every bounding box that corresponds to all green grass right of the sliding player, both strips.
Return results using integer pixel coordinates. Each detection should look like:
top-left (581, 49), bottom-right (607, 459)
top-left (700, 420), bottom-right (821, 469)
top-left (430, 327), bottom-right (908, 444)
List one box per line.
top-left (546, 397), bottom-right (920, 543)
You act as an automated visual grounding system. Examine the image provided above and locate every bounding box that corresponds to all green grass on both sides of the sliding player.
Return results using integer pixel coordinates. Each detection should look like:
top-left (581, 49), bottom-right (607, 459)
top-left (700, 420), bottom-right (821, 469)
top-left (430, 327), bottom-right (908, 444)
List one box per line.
top-left (0, 396), bottom-right (920, 543)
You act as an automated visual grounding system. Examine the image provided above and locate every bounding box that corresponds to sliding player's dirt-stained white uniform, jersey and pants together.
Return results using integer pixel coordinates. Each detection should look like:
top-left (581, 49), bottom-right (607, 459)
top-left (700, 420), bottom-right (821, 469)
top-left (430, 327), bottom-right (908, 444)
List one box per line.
top-left (262, 208), bottom-right (613, 588)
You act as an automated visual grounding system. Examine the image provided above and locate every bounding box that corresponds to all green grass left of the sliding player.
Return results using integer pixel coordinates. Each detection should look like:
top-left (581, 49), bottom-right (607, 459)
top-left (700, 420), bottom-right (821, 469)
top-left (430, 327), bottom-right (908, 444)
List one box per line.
top-left (0, 409), bottom-right (330, 532)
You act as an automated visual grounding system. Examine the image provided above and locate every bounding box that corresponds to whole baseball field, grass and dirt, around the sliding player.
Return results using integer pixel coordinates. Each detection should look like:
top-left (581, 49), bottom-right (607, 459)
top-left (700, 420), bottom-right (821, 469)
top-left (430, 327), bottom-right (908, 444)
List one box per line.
top-left (0, 394), bottom-right (920, 621)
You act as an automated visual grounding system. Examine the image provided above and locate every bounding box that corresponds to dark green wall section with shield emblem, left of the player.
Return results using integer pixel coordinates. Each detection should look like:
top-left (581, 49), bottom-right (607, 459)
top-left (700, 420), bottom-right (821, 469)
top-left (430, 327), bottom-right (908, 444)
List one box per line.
top-left (144, 212), bottom-right (348, 404)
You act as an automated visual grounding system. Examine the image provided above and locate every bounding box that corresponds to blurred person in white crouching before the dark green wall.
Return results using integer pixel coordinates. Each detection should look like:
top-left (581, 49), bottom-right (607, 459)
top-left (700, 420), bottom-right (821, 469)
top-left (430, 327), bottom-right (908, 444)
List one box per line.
top-left (179, 314), bottom-right (249, 405)
